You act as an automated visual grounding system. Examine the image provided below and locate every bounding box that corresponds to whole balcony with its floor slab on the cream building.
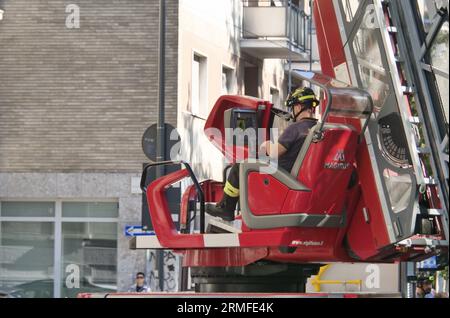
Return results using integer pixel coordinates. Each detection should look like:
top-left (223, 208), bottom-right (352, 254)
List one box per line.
top-left (240, 0), bottom-right (311, 62)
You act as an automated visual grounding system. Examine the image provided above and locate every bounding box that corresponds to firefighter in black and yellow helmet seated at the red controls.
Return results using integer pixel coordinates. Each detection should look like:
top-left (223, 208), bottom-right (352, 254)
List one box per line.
top-left (206, 87), bottom-right (319, 221)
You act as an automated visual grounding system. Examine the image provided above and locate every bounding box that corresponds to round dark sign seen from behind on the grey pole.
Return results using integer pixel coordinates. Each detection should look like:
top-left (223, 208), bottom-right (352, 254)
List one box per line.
top-left (142, 124), bottom-right (180, 161)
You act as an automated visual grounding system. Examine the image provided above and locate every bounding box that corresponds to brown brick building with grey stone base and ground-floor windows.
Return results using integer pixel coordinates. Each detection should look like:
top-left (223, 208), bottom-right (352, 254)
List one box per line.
top-left (0, 0), bottom-right (178, 297)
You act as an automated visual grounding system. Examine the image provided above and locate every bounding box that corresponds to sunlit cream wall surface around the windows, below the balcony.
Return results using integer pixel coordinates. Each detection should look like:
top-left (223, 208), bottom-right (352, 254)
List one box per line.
top-left (177, 0), bottom-right (285, 180)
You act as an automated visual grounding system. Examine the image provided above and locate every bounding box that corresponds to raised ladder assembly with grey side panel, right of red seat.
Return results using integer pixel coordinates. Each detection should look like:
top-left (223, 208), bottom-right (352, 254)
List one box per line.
top-left (333, 0), bottom-right (449, 247)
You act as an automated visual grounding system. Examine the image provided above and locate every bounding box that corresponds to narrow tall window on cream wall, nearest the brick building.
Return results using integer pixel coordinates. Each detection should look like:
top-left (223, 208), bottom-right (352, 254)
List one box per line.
top-left (191, 53), bottom-right (208, 117)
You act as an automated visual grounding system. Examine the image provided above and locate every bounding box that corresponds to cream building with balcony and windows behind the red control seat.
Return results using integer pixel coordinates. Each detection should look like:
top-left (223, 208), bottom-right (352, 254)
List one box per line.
top-left (177, 0), bottom-right (309, 180)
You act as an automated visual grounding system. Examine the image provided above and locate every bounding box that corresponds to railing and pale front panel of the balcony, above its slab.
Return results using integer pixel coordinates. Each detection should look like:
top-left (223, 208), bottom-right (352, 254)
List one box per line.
top-left (242, 0), bottom-right (312, 53)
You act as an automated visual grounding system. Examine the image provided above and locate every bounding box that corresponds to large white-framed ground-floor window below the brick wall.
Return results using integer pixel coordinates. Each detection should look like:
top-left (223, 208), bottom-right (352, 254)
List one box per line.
top-left (0, 201), bottom-right (118, 298)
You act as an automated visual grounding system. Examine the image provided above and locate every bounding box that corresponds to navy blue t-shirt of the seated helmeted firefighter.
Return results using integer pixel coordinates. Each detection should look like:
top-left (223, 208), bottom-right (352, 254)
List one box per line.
top-left (278, 118), bottom-right (317, 172)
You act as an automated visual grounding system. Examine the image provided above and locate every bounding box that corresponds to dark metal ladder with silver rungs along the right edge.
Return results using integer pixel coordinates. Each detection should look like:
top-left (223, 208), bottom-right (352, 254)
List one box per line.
top-left (382, 1), bottom-right (449, 243)
